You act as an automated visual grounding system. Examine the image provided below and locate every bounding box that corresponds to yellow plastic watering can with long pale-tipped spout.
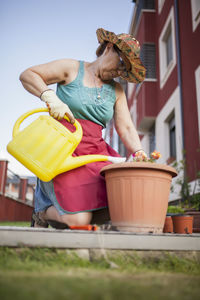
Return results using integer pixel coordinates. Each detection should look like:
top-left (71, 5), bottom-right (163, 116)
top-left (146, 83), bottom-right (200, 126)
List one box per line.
top-left (7, 108), bottom-right (126, 181)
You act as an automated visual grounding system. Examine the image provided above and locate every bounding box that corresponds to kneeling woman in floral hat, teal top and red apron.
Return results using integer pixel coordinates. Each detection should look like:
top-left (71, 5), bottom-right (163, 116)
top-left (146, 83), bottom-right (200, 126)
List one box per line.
top-left (20, 28), bottom-right (146, 227)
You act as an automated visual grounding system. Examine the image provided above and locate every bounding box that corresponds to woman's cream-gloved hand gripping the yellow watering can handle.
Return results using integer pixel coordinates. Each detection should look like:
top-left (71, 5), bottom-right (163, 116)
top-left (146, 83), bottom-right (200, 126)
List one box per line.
top-left (40, 89), bottom-right (75, 124)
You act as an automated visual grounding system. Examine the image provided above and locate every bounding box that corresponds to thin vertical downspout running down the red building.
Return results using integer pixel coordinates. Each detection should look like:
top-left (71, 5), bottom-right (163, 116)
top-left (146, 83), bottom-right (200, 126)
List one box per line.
top-left (174, 0), bottom-right (185, 152)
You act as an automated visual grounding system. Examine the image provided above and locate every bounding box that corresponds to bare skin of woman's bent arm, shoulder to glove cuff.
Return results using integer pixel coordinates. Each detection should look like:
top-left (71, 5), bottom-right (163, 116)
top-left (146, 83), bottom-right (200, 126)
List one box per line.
top-left (20, 59), bottom-right (79, 97)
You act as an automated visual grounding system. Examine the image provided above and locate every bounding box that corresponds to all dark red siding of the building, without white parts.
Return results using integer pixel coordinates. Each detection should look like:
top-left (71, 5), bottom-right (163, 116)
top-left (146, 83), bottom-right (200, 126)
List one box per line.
top-left (129, 0), bottom-right (200, 180)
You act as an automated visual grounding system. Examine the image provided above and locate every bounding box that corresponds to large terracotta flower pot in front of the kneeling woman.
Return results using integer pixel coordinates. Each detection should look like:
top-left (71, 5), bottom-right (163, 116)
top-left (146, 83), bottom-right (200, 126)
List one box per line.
top-left (101, 162), bottom-right (177, 233)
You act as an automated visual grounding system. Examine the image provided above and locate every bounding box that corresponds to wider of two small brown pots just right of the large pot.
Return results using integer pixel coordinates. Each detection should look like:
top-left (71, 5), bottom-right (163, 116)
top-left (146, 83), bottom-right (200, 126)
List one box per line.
top-left (172, 215), bottom-right (193, 234)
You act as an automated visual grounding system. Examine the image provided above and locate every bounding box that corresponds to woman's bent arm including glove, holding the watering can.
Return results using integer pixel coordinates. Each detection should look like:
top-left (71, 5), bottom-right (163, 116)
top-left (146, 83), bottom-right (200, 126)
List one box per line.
top-left (20, 59), bottom-right (79, 123)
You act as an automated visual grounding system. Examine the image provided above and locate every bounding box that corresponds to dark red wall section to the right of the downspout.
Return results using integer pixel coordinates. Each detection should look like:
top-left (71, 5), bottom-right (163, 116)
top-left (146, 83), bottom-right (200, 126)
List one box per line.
top-left (179, 0), bottom-right (200, 179)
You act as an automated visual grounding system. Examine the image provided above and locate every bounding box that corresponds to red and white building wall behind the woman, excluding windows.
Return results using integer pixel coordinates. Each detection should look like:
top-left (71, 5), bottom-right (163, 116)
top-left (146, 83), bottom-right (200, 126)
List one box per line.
top-left (129, 0), bottom-right (200, 186)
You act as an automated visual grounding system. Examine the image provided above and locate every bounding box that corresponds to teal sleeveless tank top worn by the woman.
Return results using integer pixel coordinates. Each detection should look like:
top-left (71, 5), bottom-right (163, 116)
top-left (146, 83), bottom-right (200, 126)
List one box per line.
top-left (56, 61), bottom-right (116, 127)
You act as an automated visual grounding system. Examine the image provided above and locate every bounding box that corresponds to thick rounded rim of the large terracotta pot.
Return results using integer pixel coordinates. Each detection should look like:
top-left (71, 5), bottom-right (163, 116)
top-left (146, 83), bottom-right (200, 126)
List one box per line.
top-left (100, 162), bottom-right (178, 177)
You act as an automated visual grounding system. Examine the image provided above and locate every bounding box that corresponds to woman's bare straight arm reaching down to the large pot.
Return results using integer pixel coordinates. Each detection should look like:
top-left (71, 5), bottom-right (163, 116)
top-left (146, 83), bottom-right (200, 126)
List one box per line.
top-left (114, 83), bottom-right (142, 153)
